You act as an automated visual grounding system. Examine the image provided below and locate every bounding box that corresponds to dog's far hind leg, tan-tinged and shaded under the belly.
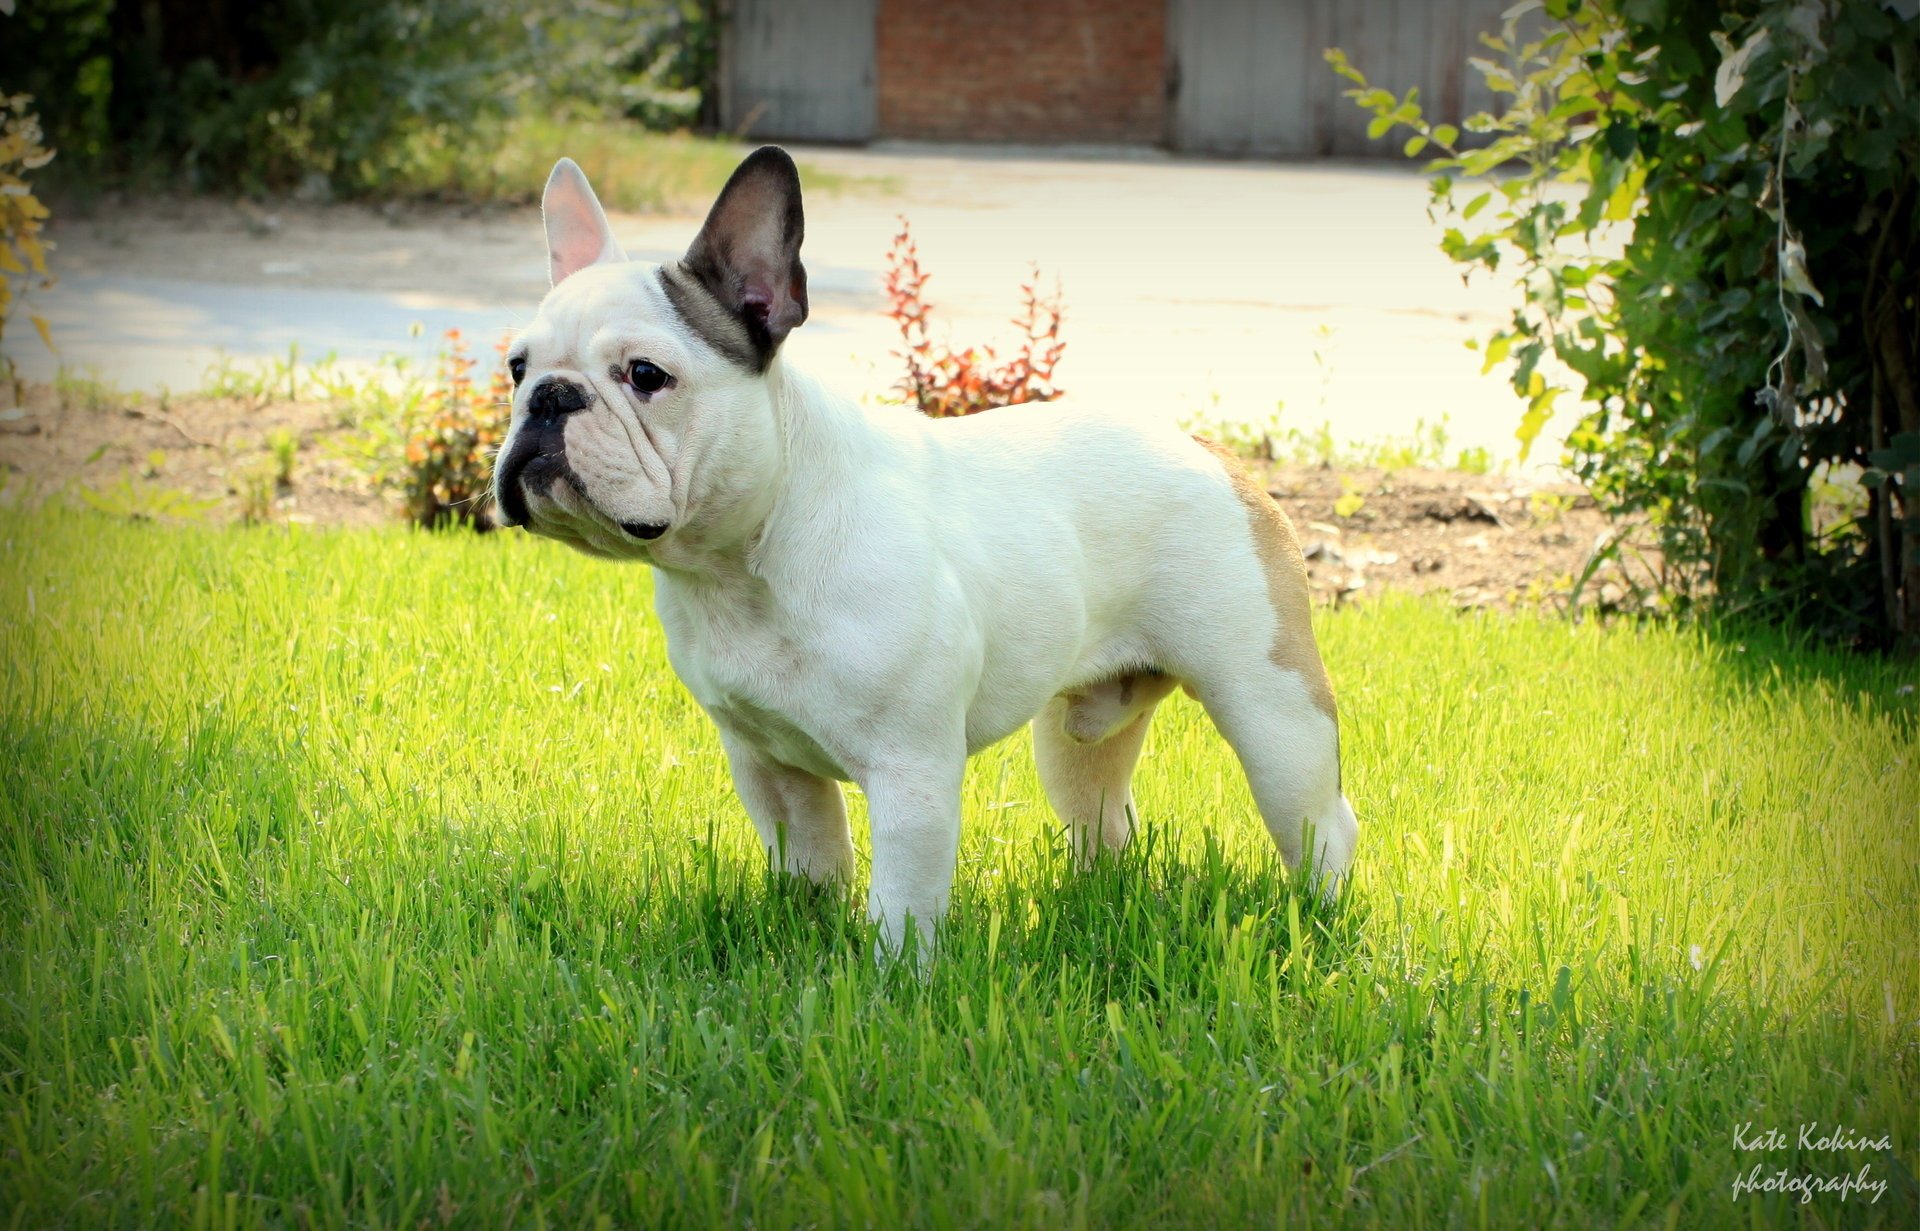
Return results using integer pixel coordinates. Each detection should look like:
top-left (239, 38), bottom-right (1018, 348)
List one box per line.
top-left (1033, 674), bottom-right (1175, 868)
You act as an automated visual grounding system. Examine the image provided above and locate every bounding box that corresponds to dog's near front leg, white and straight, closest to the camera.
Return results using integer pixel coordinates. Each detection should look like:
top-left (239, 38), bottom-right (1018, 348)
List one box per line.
top-left (860, 747), bottom-right (966, 956)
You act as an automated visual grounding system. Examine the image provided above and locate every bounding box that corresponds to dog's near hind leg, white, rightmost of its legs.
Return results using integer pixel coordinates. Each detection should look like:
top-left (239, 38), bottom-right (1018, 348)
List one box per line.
top-left (1196, 663), bottom-right (1359, 895)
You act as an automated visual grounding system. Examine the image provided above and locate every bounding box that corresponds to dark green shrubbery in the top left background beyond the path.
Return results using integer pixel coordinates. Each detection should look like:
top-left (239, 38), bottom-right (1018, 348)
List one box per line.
top-left (0, 0), bottom-right (714, 194)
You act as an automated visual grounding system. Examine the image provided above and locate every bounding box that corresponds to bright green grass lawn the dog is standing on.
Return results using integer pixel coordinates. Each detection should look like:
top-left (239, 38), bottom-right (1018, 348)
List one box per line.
top-left (0, 511), bottom-right (1920, 1229)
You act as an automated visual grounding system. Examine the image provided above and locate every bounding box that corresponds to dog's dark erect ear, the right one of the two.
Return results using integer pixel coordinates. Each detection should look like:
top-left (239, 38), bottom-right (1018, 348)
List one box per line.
top-left (684, 146), bottom-right (806, 367)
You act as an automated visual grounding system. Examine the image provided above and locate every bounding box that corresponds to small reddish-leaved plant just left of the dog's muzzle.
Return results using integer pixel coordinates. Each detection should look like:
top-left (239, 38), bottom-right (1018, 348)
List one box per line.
top-left (399, 328), bottom-right (513, 530)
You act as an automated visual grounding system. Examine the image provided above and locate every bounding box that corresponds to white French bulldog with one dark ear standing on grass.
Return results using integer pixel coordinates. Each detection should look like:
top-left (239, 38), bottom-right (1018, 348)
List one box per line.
top-left (493, 146), bottom-right (1359, 951)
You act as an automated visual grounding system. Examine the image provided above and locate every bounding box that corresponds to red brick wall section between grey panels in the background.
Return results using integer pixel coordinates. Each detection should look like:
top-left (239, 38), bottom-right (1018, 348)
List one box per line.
top-left (876, 0), bottom-right (1167, 142)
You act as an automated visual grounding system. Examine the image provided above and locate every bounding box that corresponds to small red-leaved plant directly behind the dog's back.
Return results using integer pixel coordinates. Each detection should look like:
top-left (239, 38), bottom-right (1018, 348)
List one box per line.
top-left (887, 217), bottom-right (1066, 419)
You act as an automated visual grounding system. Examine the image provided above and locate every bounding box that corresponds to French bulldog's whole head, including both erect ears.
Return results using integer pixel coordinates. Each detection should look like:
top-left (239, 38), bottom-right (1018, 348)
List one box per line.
top-left (493, 146), bottom-right (806, 563)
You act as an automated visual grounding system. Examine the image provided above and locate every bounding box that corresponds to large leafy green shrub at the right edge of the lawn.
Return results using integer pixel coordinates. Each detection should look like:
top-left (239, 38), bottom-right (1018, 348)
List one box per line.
top-left (1329, 0), bottom-right (1920, 647)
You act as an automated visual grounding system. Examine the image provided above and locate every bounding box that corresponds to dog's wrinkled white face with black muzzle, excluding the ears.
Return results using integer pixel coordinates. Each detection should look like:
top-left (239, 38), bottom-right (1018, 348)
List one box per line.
top-left (493, 261), bottom-right (778, 559)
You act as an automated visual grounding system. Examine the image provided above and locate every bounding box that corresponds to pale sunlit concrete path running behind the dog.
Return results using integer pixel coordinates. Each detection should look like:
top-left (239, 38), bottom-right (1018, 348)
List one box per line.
top-left (13, 146), bottom-right (1567, 459)
